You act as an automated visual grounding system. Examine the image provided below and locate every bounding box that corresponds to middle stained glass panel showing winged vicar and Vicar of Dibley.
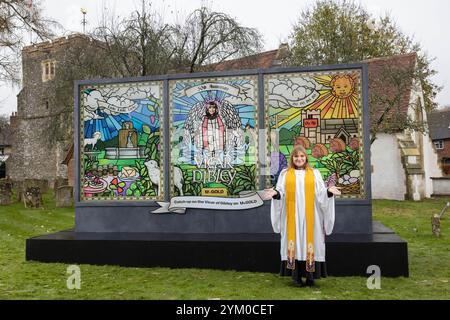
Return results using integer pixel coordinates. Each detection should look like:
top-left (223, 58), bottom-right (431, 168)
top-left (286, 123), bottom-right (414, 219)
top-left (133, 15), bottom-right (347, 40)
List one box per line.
top-left (169, 77), bottom-right (258, 197)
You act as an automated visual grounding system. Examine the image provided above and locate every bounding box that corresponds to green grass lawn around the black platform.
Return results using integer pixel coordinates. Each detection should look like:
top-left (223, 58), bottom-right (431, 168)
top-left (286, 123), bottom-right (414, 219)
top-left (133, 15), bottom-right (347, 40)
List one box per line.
top-left (0, 195), bottom-right (450, 300)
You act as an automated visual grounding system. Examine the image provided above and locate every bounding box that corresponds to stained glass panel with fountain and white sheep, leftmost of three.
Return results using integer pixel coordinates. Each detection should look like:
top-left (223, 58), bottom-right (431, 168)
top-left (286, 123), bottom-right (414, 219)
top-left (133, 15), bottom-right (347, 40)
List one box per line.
top-left (80, 82), bottom-right (163, 200)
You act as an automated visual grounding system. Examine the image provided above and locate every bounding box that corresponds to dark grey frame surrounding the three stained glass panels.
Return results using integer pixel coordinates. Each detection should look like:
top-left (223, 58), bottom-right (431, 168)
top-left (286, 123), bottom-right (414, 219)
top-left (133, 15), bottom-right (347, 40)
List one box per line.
top-left (74, 64), bottom-right (371, 211)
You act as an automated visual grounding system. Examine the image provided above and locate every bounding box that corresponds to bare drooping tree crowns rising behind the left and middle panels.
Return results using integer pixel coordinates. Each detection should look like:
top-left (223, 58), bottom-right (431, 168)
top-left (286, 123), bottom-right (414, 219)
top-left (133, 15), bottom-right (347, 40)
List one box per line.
top-left (92, 0), bottom-right (262, 77)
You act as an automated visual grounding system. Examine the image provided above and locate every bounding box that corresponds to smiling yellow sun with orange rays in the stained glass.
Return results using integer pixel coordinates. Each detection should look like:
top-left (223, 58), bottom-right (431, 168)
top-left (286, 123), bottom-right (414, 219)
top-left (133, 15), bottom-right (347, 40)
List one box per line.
top-left (305, 74), bottom-right (358, 119)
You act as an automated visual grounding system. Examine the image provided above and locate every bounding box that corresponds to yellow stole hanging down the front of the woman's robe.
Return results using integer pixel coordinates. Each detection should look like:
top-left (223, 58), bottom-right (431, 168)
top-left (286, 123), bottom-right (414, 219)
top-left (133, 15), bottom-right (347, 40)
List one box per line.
top-left (285, 168), bottom-right (314, 272)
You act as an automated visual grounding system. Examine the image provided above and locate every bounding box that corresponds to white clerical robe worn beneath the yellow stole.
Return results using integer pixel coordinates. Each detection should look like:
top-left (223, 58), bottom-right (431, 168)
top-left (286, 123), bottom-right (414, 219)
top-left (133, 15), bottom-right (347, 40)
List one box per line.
top-left (270, 169), bottom-right (334, 262)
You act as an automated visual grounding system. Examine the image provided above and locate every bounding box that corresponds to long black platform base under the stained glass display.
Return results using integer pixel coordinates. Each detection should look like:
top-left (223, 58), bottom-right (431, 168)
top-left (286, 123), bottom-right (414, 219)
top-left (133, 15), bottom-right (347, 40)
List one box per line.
top-left (26, 223), bottom-right (409, 277)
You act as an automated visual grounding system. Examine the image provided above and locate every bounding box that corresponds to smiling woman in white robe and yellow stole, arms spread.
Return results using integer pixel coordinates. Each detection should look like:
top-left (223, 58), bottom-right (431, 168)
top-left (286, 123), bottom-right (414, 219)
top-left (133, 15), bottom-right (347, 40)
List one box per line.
top-left (265, 146), bottom-right (341, 286)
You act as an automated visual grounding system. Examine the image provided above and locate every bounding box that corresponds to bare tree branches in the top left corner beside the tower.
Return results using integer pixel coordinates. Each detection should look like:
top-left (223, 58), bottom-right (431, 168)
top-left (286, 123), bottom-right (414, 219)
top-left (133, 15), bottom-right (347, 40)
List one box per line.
top-left (0, 0), bottom-right (59, 82)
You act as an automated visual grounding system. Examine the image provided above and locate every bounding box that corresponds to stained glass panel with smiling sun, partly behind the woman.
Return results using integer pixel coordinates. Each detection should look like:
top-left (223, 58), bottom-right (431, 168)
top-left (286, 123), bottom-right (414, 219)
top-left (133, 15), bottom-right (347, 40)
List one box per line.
top-left (264, 70), bottom-right (364, 198)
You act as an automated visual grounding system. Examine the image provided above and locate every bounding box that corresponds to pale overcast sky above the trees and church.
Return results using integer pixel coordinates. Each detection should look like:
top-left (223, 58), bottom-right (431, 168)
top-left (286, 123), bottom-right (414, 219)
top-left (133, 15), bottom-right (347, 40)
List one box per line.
top-left (0, 0), bottom-right (450, 114)
